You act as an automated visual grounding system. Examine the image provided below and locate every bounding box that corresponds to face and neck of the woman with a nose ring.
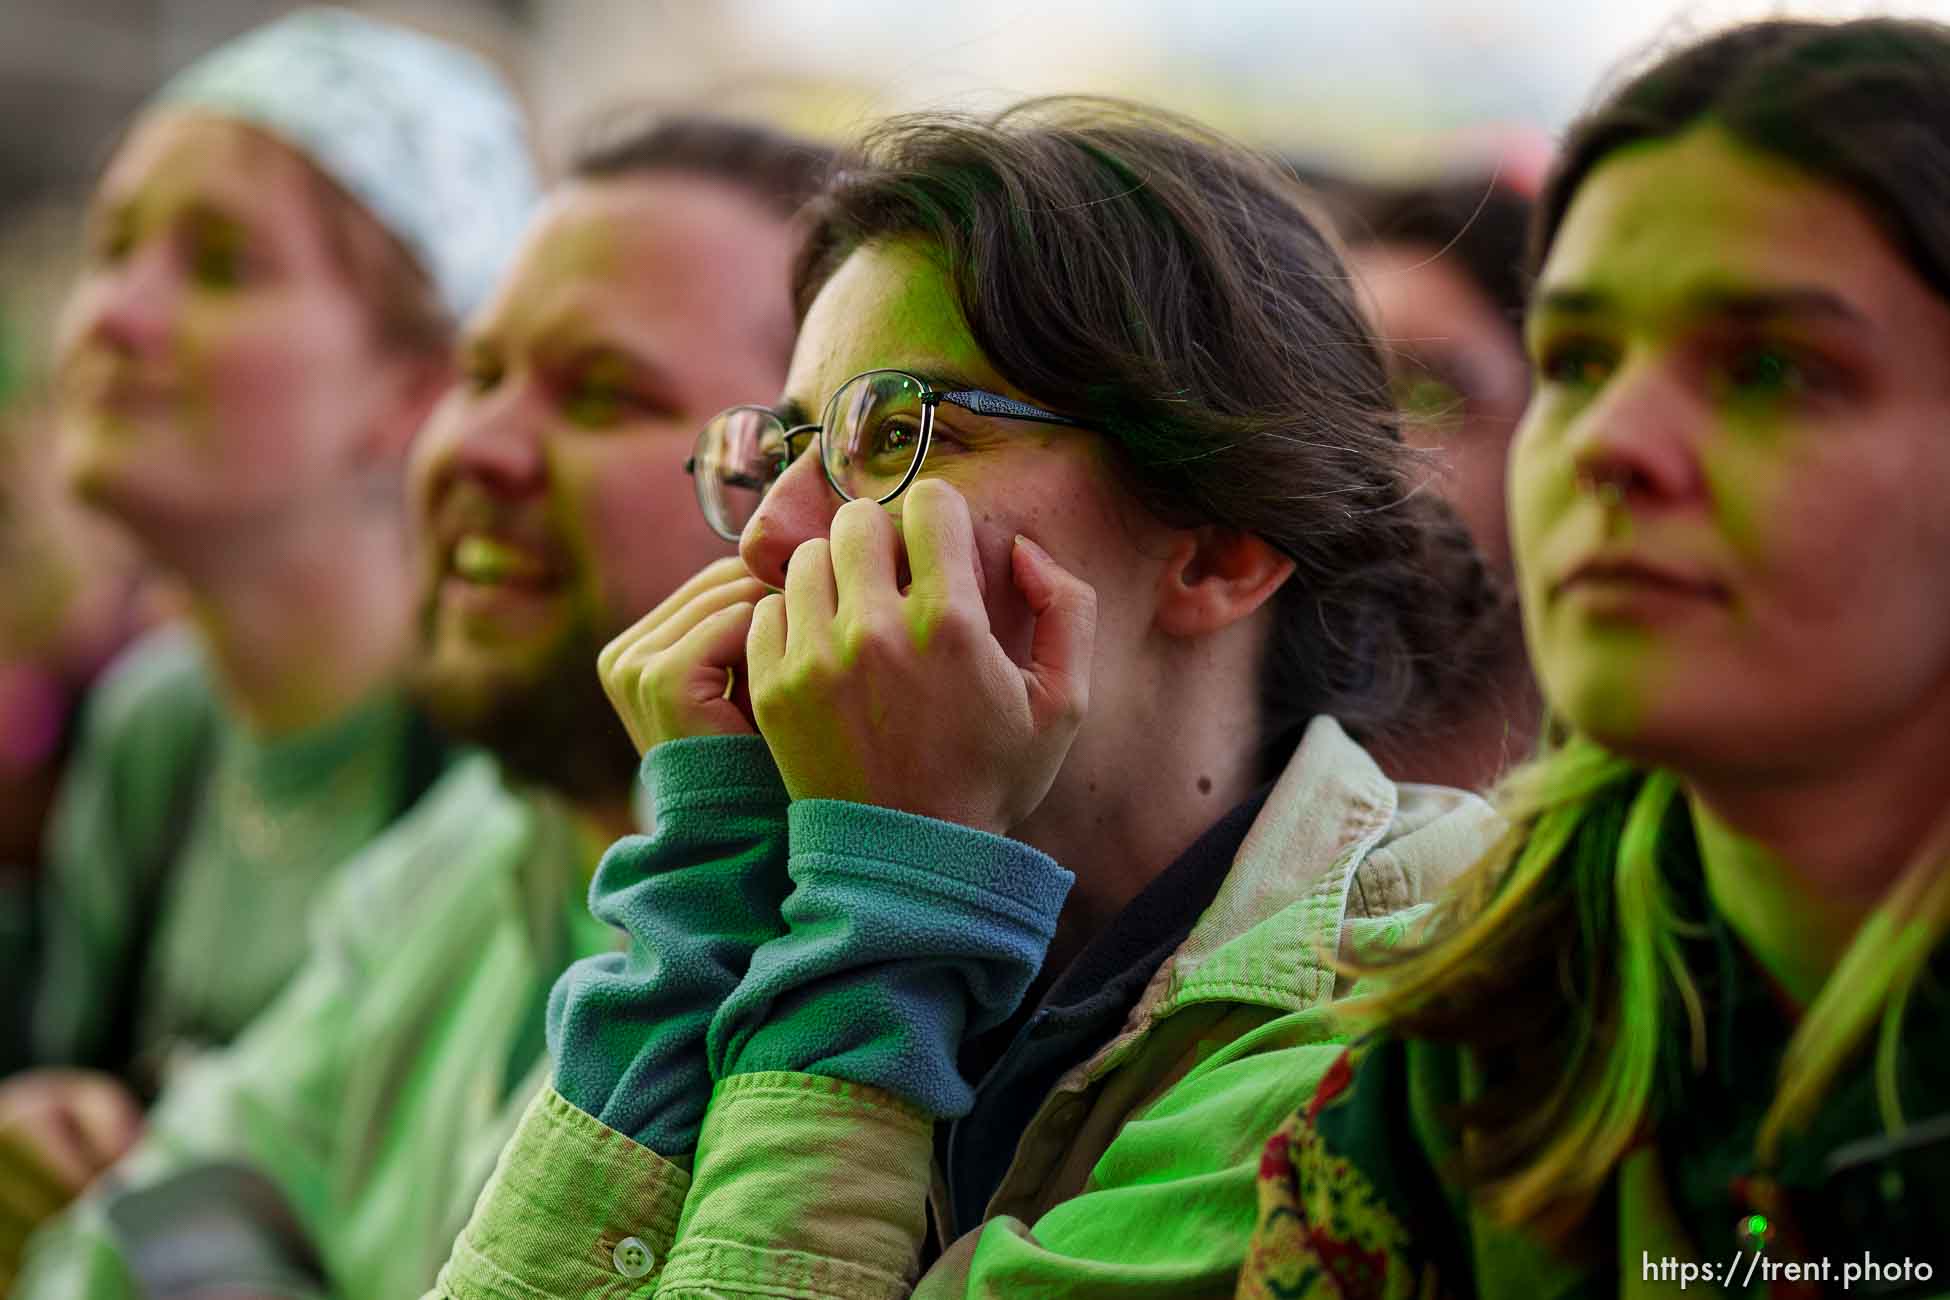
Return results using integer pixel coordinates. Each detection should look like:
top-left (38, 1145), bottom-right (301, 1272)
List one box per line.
top-left (1511, 127), bottom-right (1950, 996)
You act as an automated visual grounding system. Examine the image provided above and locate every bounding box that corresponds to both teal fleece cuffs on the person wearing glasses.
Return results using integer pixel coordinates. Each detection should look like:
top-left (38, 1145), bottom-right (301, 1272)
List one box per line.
top-left (548, 737), bottom-right (1074, 1154)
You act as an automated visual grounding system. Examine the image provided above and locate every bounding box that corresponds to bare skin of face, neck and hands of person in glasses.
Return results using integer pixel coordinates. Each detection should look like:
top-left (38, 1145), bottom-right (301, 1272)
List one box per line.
top-left (606, 242), bottom-right (1293, 969)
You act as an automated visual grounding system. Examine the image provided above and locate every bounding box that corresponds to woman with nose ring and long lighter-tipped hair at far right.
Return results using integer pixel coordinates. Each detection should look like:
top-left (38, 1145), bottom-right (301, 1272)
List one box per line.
top-left (1240, 21), bottom-right (1950, 1298)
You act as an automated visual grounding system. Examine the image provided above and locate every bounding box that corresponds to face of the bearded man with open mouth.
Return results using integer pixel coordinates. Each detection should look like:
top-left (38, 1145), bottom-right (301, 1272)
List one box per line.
top-left (411, 172), bottom-right (798, 789)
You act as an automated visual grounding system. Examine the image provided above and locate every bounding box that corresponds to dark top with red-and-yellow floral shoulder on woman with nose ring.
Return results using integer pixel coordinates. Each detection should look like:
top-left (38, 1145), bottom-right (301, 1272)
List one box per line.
top-left (1238, 822), bottom-right (1950, 1300)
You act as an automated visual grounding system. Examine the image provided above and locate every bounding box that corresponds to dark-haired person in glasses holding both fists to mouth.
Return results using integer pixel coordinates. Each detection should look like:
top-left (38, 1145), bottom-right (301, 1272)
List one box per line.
top-left (443, 101), bottom-right (1494, 1296)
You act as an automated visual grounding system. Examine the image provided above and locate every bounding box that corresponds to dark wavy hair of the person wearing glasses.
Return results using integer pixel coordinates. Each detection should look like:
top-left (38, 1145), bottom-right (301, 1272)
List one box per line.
top-left (796, 97), bottom-right (1498, 764)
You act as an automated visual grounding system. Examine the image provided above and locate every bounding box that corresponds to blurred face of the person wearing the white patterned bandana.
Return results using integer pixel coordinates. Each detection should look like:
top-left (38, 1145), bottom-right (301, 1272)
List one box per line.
top-left (59, 113), bottom-right (417, 550)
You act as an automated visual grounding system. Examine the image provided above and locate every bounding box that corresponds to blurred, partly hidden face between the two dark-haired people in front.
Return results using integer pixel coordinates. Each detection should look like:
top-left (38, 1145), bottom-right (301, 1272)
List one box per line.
top-left (1347, 242), bottom-right (1529, 575)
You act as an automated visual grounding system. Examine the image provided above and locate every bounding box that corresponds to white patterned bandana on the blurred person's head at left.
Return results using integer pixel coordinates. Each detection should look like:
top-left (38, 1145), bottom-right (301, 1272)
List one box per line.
top-left (152, 8), bottom-right (536, 322)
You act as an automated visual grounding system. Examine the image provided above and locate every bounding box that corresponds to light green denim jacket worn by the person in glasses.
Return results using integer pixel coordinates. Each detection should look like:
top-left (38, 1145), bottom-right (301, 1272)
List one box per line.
top-left (435, 717), bottom-right (1498, 1300)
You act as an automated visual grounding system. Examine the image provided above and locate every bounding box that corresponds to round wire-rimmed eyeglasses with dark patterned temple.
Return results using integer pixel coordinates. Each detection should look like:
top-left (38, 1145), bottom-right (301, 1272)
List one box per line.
top-left (684, 370), bottom-right (1084, 542)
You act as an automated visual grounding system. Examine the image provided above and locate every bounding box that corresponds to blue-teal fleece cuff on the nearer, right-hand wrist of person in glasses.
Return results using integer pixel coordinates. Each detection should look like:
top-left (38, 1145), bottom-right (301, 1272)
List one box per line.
top-left (710, 799), bottom-right (1076, 1119)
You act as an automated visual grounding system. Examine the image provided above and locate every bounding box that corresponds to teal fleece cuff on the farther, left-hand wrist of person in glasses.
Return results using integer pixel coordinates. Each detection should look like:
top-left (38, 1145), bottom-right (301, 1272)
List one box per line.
top-left (548, 737), bottom-right (792, 1156)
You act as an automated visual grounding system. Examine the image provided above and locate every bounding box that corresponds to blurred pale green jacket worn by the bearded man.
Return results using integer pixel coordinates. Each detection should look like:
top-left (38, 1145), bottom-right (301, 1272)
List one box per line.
top-left (16, 756), bottom-right (618, 1300)
